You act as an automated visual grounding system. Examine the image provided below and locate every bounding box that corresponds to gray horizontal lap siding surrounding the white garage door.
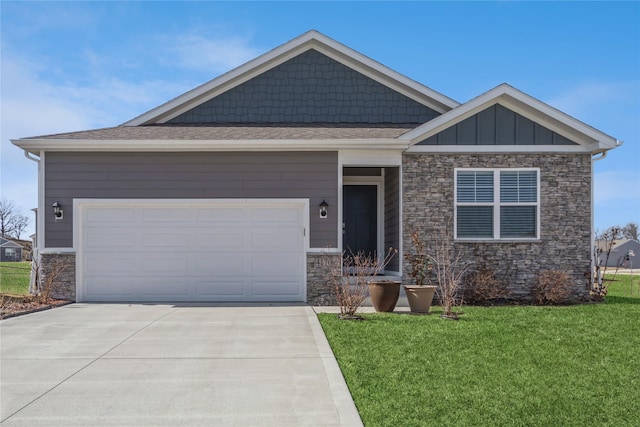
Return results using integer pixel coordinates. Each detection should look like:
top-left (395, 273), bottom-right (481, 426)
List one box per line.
top-left (45, 152), bottom-right (338, 248)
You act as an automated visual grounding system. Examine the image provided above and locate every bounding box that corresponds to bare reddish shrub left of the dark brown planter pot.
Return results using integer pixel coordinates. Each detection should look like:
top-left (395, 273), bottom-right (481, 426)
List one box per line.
top-left (331, 248), bottom-right (398, 319)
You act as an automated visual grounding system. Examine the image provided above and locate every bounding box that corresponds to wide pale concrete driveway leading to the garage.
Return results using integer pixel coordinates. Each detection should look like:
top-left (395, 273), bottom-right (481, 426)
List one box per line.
top-left (0, 304), bottom-right (362, 427)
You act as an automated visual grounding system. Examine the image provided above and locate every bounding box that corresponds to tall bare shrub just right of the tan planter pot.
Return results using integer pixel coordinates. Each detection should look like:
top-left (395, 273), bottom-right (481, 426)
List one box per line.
top-left (428, 221), bottom-right (473, 319)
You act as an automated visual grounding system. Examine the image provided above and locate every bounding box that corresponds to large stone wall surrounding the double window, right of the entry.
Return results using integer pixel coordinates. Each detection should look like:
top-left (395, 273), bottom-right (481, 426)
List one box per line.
top-left (403, 153), bottom-right (592, 302)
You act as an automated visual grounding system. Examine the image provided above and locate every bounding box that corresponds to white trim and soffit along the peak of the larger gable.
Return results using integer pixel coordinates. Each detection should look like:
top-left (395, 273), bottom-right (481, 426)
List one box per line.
top-left (124, 30), bottom-right (460, 126)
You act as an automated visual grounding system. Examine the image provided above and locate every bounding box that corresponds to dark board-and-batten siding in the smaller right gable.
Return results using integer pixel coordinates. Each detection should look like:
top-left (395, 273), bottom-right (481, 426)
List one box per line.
top-left (418, 104), bottom-right (576, 145)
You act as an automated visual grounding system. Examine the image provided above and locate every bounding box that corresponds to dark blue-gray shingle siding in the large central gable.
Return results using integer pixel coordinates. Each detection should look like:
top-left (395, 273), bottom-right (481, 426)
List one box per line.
top-left (168, 49), bottom-right (439, 124)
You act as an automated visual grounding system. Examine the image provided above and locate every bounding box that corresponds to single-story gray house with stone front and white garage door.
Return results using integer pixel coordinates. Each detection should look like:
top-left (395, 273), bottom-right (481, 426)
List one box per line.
top-left (12, 31), bottom-right (620, 304)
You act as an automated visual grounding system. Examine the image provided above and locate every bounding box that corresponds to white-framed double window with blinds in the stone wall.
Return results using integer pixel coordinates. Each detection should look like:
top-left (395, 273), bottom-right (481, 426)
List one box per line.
top-left (454, 168), bottom-right (540, 240)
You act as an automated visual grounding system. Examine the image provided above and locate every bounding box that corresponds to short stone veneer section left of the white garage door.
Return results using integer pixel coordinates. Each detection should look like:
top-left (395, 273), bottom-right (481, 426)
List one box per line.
top-left (39, 253), bottom-right (76, 301)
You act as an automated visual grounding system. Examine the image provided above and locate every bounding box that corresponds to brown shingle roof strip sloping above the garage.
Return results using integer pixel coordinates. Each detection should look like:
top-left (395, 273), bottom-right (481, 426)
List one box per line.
top-left (26, 124), bottom-right (419, 140)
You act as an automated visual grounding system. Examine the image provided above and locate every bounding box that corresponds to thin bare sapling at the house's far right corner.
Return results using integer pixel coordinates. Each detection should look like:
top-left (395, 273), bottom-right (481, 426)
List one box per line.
top-left (589, 227), bottom-right (622, 299)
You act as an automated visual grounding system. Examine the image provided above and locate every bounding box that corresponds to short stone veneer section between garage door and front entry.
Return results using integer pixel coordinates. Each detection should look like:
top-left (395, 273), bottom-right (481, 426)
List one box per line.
top-left (307, 254), bottom-right (342, 305)
